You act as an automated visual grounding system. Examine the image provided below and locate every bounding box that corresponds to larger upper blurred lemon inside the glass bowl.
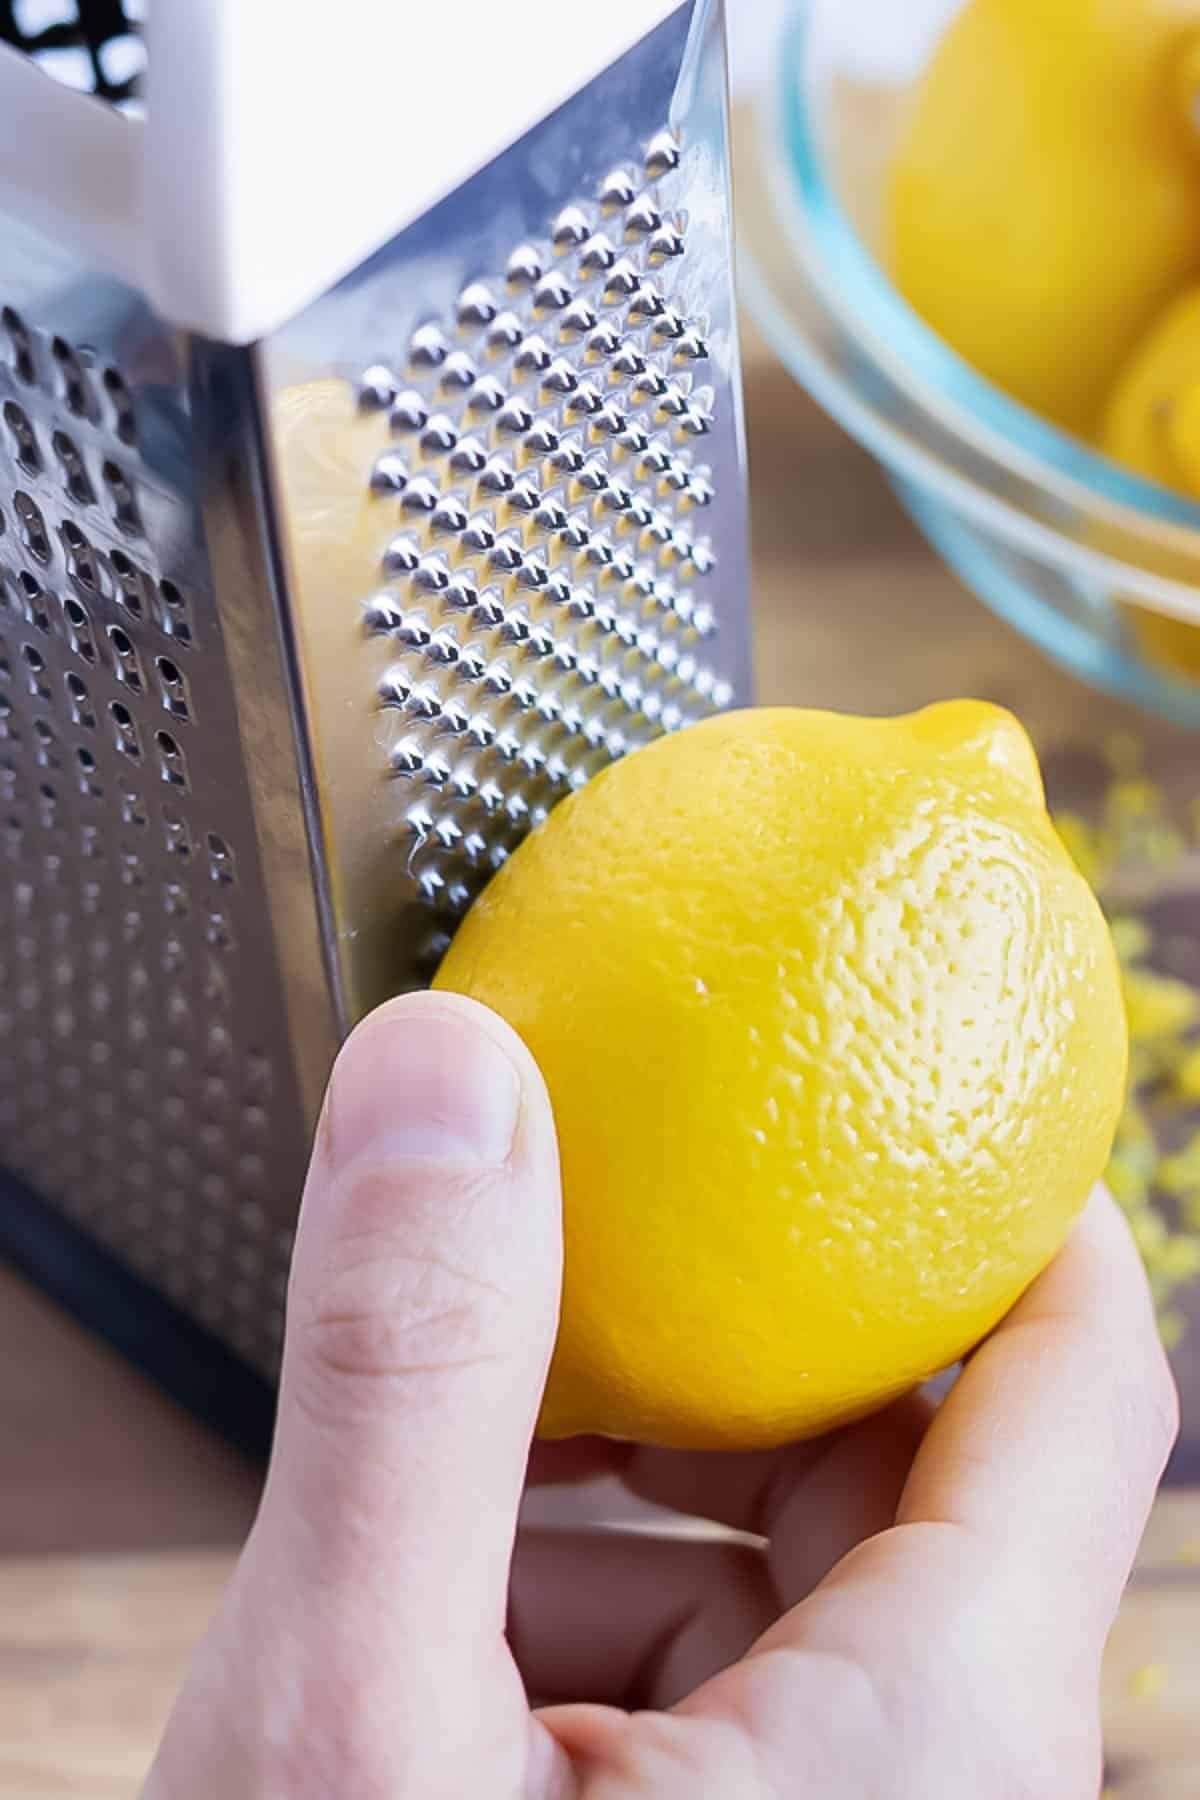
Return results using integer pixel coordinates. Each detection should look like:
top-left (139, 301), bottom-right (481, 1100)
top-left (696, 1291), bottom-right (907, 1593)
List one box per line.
top-left (889, 0), bottom-right (1200, 436)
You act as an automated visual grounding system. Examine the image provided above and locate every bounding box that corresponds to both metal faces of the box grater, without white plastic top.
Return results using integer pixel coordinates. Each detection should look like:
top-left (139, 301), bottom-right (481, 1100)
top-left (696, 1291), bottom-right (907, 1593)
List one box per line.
top-left (0, 0), bottom-right (748, 1432)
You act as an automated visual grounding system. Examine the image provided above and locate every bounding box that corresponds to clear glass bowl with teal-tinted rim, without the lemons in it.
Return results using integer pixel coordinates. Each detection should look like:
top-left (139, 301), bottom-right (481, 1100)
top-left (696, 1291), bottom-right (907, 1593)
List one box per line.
top-left (738, 0), bottom-right (1200, 727)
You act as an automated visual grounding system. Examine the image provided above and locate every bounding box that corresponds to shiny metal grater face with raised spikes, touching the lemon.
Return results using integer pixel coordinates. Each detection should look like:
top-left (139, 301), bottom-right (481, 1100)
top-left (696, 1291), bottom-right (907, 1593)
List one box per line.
top-left (263, 7), bottom-right (748, 1015)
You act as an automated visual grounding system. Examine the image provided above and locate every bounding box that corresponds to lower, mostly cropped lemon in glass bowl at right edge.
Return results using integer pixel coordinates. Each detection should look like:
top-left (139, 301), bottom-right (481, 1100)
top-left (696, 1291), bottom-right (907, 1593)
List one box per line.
top-left (1101, 286), bottom-right (1200, 679)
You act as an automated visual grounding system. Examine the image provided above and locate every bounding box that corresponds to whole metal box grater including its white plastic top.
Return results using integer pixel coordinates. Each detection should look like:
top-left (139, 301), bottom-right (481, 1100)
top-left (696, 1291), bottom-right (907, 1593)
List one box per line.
top-left (0, 0), bottom-right (748, 1440)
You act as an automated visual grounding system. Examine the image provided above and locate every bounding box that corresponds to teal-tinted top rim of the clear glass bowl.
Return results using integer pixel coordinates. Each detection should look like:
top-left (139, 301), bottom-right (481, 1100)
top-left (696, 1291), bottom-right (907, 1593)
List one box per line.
top-left (777, 0), bottom-right (1200, 533)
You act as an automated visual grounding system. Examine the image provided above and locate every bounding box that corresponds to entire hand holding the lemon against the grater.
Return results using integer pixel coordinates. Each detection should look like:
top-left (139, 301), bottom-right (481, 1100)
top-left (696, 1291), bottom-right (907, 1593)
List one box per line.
top-left (144, 995), bottom-right (1177, 1800)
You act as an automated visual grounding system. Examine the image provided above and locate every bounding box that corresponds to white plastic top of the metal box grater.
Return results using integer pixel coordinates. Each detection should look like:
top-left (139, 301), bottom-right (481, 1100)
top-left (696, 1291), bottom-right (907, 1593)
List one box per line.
top-left (0, 0), bottom-right (680, 344)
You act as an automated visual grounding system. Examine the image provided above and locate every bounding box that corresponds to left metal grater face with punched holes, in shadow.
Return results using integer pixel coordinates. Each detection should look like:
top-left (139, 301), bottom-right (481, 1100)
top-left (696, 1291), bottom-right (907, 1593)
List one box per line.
top-left (0, 292), bottom-right (304, 1375)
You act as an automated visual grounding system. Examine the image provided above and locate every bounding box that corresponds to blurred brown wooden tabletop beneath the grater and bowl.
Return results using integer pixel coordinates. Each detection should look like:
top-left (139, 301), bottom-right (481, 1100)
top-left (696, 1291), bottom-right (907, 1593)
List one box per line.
top-left (0, 338), bottom-right (1200, 1800)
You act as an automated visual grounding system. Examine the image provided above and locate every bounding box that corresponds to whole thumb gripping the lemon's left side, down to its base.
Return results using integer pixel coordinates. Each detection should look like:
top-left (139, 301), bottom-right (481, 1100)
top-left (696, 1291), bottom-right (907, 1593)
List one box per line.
top-left (147, 994), bottom-right (561, 1793)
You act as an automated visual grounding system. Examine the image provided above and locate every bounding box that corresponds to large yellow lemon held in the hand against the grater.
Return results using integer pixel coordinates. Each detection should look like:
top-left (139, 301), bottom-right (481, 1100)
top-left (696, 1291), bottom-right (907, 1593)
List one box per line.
top-left (437, 702), bottom-right (1126, 1447)
